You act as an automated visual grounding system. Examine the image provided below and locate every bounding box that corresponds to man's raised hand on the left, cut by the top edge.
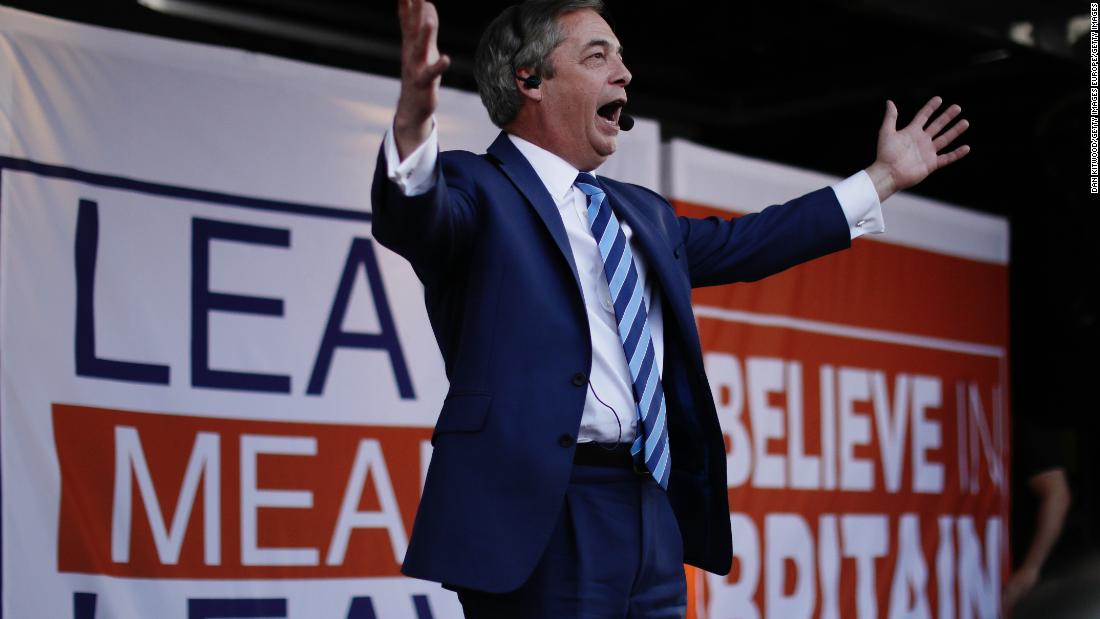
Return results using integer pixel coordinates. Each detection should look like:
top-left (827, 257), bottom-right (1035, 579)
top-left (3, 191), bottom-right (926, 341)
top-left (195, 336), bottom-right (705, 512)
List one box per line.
top-left (394, 0), bottom-right (451, 159)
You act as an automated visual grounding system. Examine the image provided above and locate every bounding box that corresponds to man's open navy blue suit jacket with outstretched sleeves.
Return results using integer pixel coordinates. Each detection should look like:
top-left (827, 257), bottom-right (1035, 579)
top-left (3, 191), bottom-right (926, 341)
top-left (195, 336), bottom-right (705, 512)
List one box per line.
top-left (371, 133), bottom-right (850, 593)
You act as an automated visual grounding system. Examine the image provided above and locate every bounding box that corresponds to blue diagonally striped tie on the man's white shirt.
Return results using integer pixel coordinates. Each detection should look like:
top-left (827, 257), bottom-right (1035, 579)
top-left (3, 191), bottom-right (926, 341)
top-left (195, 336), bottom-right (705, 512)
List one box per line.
top-left (574, 172), bottom-right (671, 490)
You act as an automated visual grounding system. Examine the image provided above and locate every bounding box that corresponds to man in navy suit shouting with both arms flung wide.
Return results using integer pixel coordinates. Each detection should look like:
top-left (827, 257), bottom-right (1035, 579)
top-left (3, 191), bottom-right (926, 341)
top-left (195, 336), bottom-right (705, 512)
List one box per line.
top-left (372, 0), bottom-right (968, 619)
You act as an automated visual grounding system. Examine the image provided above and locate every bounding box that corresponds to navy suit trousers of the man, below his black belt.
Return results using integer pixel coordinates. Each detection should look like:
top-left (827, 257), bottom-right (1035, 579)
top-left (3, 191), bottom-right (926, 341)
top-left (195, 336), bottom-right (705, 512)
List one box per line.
top-left (458, 464), bottom-right (688, 619)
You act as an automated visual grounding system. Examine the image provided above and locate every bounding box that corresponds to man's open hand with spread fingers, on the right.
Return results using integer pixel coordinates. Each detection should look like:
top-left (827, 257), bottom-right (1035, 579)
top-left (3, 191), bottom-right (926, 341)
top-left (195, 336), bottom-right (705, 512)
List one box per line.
top-left (866, 97), bottom-right (970, 202)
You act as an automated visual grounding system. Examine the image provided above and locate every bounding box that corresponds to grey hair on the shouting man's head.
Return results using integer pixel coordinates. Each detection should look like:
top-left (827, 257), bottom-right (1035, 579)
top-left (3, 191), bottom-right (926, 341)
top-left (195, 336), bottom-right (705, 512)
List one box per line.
top-left (474, 0), bottom-right (604, 128)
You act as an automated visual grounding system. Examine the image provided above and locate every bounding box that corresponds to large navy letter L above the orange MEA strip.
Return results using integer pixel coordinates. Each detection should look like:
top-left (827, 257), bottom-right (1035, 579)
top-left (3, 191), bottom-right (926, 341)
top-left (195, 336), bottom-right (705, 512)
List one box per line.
top-left (73, 200), bottom-right (169, 385)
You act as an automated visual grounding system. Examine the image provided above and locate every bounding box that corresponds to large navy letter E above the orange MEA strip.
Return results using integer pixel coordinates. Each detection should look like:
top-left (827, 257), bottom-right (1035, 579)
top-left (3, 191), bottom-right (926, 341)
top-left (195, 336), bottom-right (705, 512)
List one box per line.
top-left (191, 218), bottom-right (290, 394)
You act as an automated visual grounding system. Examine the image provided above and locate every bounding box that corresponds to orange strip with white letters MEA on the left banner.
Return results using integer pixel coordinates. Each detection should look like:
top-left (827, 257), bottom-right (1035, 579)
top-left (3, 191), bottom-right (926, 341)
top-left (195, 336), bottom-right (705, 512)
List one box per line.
top-left (53, 405), bottom-right (430, 578)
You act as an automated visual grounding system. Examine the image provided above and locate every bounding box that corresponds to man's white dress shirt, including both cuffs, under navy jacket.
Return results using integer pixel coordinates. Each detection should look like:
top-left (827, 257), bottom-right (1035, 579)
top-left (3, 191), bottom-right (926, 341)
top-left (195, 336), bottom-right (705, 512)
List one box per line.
top-left (385, 124), bottom-right (884, 443)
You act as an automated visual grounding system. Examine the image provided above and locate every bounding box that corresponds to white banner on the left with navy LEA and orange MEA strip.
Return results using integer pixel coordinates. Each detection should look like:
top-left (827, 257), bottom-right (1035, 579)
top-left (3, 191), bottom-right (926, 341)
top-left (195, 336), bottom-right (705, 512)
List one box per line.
top-left (0, 9), bottom-right (660, 619)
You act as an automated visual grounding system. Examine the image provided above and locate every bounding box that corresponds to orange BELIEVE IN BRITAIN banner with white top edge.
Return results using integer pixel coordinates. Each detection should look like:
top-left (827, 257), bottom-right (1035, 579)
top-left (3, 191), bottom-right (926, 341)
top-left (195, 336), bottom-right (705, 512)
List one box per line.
top-left (667, 140), bottom-right (1009, 619)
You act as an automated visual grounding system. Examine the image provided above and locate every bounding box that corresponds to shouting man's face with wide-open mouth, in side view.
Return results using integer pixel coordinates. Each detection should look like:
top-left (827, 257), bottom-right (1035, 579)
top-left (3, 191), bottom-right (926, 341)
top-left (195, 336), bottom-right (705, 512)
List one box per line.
top-left (530, 10), bottom-right (630, 172)
